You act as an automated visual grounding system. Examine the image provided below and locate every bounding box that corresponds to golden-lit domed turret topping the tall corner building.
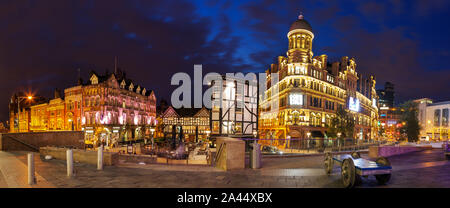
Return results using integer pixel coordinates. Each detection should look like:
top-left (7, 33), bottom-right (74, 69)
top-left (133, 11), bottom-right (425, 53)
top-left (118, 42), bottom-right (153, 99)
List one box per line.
top-left (287, 15), bottom-right (314, 63)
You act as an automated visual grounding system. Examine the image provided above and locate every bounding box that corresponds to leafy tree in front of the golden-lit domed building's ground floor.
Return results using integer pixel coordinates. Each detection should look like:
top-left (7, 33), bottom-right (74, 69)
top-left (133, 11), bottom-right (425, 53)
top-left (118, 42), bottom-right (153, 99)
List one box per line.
top-left (327, 108), bottom-right (355, 142)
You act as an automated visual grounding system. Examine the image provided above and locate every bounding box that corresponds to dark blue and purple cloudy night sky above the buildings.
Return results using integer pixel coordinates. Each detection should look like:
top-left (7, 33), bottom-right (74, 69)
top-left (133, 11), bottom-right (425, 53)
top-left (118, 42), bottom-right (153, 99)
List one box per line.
top-left (0, 0), bottom-right (450, 121)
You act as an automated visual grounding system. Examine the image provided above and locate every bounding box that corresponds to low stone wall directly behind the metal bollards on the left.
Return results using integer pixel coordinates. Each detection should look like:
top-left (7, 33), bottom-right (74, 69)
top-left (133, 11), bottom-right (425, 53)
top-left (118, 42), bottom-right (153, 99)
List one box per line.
top-left (39, 147), bottom-right (119, 165)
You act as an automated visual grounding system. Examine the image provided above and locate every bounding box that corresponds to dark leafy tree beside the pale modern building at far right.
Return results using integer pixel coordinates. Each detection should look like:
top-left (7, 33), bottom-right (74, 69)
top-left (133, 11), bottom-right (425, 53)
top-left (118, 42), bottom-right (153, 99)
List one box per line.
top-left (400, 101), bottom-right (421, 142)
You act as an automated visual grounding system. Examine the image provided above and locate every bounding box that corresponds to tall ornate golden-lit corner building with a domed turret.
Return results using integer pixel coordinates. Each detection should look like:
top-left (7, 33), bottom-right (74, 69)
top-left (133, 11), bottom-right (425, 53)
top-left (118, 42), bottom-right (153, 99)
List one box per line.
top-left (258, 15), bottom-right (378, 147)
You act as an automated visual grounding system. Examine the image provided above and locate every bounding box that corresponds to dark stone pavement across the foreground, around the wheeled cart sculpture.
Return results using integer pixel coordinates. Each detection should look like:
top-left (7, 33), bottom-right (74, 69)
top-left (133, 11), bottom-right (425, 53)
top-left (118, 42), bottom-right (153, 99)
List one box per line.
top-left (0, 150), bottom-right (450, 188)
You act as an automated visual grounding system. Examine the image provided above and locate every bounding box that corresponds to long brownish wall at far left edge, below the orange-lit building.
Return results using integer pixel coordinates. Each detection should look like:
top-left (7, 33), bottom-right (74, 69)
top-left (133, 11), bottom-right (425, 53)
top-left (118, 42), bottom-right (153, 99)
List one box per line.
top-left (0, 131), bottom-right (84, 151)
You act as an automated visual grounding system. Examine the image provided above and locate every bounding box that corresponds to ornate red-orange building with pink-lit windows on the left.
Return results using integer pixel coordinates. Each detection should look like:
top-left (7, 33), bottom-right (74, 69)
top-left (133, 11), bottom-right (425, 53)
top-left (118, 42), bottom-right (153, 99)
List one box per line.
top-left (10, 68), bottom-right (157, 148)
